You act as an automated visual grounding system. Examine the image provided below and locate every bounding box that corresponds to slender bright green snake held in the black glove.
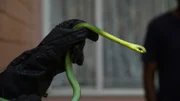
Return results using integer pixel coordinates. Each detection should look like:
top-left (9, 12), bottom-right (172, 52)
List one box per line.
top-left (0, 23), bottom-right (146, 101)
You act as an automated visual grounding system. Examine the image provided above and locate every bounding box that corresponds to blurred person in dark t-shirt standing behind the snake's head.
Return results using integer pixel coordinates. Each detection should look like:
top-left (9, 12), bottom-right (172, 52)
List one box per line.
top-left (142, 0), bottom-right (180, 101)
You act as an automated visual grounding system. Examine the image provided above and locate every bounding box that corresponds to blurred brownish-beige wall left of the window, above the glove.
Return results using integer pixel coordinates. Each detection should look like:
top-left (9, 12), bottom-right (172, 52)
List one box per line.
top-left (0, 0), bottom-right (41, 70)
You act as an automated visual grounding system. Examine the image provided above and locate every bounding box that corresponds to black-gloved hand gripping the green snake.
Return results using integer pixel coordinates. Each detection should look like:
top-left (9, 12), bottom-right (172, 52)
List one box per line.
top-left (0, 19), bottom-right (98, 99)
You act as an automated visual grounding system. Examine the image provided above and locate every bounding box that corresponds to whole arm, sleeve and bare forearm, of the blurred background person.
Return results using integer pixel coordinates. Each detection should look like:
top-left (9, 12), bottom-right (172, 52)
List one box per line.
top-left (142, 21), bottom-right (159, 101)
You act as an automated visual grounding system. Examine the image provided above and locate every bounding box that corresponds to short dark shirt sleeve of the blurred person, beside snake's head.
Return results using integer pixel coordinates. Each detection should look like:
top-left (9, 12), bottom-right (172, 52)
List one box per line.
top-left (142, 22), bottom-right (159, 62)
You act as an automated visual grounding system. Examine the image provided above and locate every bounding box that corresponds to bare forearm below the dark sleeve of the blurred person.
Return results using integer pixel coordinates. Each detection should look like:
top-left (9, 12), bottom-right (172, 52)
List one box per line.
top-left (143, 62), bottom-right (157, 101)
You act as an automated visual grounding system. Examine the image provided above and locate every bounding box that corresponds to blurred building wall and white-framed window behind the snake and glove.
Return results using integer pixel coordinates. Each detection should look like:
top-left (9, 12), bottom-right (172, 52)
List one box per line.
top-left (0, 0), bottom-right (176, 101)
